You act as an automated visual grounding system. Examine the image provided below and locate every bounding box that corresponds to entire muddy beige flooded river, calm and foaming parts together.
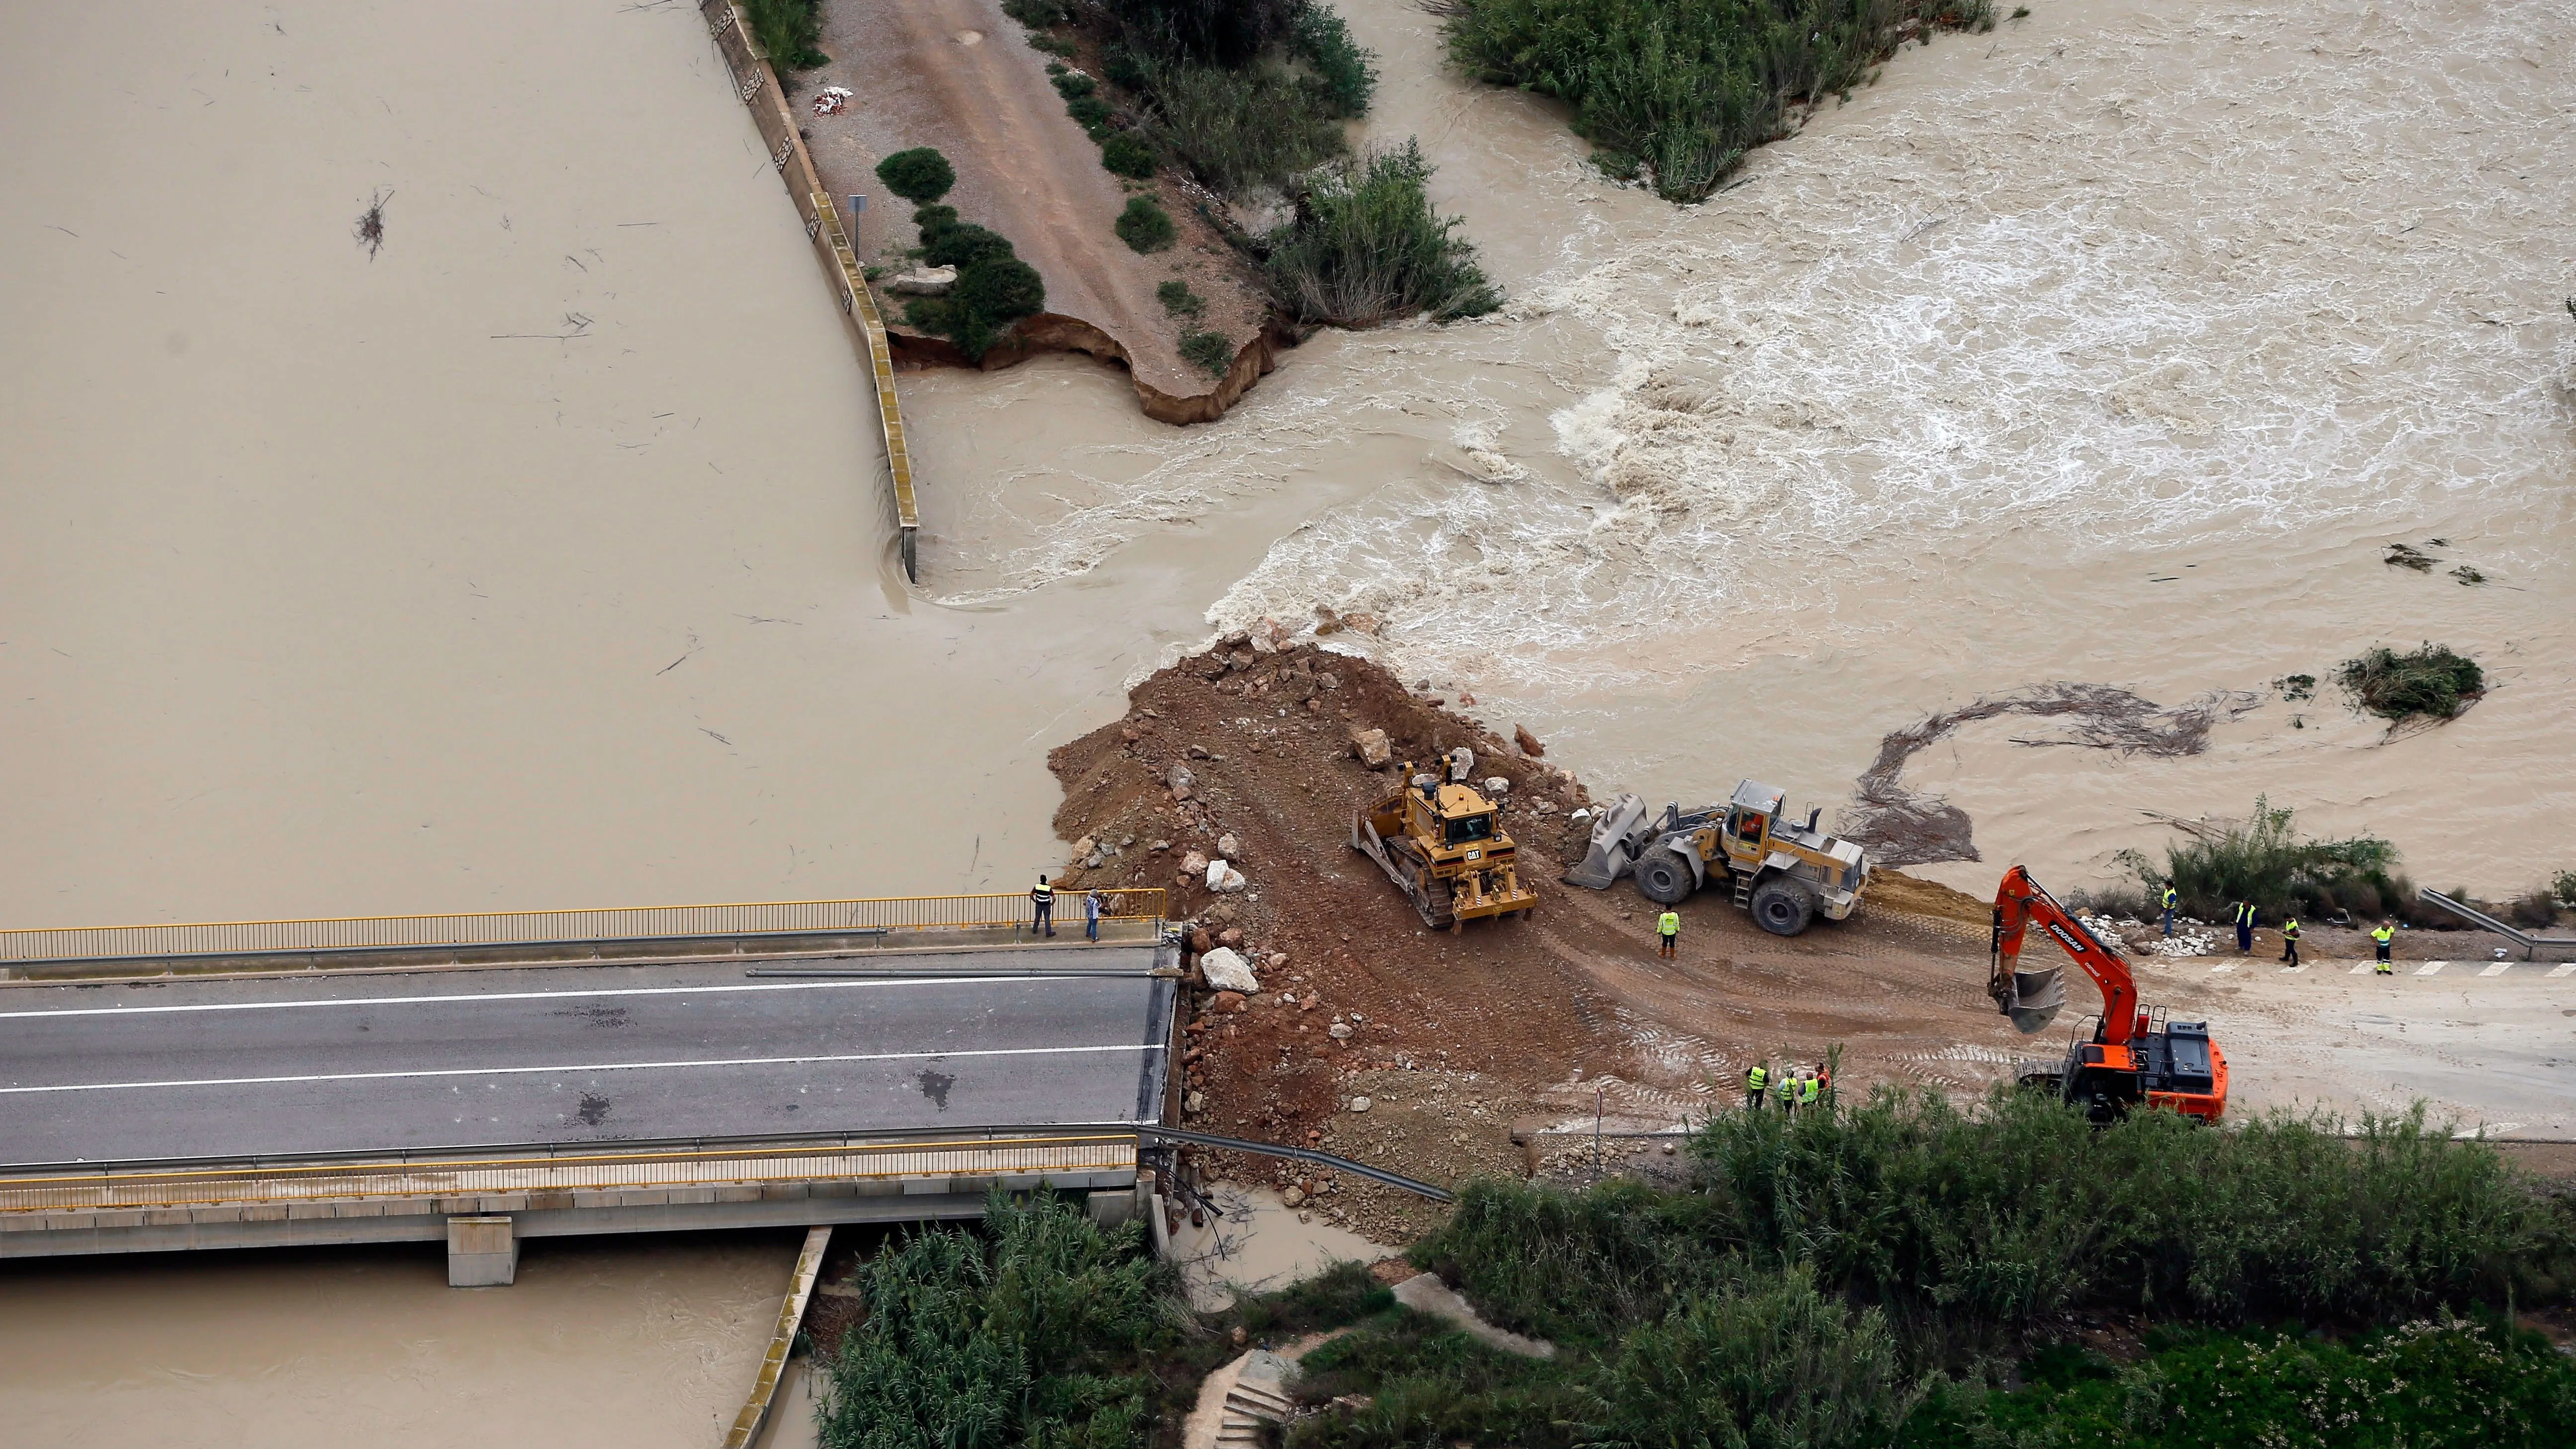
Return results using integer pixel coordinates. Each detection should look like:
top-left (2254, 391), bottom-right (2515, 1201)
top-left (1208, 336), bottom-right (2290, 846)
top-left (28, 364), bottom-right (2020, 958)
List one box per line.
top-left (0, 0), bottom-right (2576, 1444)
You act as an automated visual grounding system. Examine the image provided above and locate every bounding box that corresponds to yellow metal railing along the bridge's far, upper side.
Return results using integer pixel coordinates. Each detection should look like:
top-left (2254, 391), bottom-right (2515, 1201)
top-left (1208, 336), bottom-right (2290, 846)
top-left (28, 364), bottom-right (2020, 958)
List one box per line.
top-left (0, 887), bottom-right (1164, 965)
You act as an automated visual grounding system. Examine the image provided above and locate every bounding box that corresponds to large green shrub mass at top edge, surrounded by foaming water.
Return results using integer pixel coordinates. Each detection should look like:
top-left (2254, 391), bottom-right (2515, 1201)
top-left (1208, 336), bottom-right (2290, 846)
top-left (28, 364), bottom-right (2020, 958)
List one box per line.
top-left (1445, 0), bottom-right (1994, 201)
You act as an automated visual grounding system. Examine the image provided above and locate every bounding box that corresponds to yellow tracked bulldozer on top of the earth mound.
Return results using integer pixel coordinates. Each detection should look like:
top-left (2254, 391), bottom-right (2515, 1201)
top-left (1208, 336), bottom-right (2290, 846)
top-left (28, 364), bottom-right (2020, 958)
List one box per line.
top-left (1350, 750), bottom-right (1538, 931)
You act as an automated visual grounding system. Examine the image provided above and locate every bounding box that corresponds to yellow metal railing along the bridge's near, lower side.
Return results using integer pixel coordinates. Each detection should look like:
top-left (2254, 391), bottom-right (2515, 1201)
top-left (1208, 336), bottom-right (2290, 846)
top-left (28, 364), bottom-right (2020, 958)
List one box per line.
top-left (0, 1132), bottom-right (1136, 1214)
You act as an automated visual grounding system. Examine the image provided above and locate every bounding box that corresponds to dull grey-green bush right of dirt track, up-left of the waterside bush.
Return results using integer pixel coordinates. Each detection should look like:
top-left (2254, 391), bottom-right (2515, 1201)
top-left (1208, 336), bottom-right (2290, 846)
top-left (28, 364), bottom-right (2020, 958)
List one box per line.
top-left (1146, 62), bottom-right (1345, 196)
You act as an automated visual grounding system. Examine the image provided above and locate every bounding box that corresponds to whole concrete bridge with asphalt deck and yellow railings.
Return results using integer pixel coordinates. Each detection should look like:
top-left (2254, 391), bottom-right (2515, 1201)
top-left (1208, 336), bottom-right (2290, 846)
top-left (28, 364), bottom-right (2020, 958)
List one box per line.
top-left (0, 892), bottom-right (1180, 1284)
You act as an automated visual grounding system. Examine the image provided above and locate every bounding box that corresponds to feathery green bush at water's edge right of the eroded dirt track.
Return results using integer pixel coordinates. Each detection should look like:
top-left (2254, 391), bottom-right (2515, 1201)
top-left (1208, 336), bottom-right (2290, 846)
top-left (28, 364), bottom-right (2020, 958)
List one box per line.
top-left (1265, 139), bottom-right (1502, 327)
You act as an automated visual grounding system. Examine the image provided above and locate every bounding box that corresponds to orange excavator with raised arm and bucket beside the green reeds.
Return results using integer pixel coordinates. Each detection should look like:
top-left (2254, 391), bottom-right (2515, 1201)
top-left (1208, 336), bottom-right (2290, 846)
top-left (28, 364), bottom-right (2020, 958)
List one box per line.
top-left (1986, 866), bottom-right (2228, 1122)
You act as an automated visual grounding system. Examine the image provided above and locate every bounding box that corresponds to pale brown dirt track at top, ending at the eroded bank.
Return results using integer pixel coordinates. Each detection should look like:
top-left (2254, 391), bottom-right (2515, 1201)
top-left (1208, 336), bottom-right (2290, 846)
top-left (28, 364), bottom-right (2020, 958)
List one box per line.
top-left (788, 0), bottom-right (1244, 397)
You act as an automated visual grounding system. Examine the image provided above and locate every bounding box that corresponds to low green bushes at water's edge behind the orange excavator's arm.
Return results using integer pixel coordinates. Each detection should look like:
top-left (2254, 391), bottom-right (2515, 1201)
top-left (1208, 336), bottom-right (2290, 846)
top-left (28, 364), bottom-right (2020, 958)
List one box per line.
top-left (2117, 797), bottom-right (2414, 920)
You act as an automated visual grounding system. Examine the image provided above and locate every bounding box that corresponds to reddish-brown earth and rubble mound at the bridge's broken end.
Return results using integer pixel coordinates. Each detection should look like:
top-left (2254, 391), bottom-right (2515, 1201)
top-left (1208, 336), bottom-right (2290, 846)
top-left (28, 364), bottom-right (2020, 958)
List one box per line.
top-left (1048, 640), bottom-right (2012, 1240)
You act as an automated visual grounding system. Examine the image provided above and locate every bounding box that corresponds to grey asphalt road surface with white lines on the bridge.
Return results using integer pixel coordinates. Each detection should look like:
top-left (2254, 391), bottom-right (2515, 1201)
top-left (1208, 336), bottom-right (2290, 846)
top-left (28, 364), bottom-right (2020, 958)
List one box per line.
top-left (0, 946), bottom-right (1175, 1165)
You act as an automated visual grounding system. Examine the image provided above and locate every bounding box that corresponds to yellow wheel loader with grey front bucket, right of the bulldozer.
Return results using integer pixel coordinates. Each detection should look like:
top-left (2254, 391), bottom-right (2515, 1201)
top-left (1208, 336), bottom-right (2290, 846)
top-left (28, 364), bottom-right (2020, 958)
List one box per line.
top-left (1564, 781), bottom-right (1870, 936)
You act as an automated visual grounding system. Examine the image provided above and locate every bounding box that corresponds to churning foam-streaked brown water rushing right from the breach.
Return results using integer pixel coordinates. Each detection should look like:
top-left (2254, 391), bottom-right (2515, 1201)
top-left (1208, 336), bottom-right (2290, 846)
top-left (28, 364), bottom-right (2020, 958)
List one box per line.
top-left (917, 0), bottom-right (2576, 889)
